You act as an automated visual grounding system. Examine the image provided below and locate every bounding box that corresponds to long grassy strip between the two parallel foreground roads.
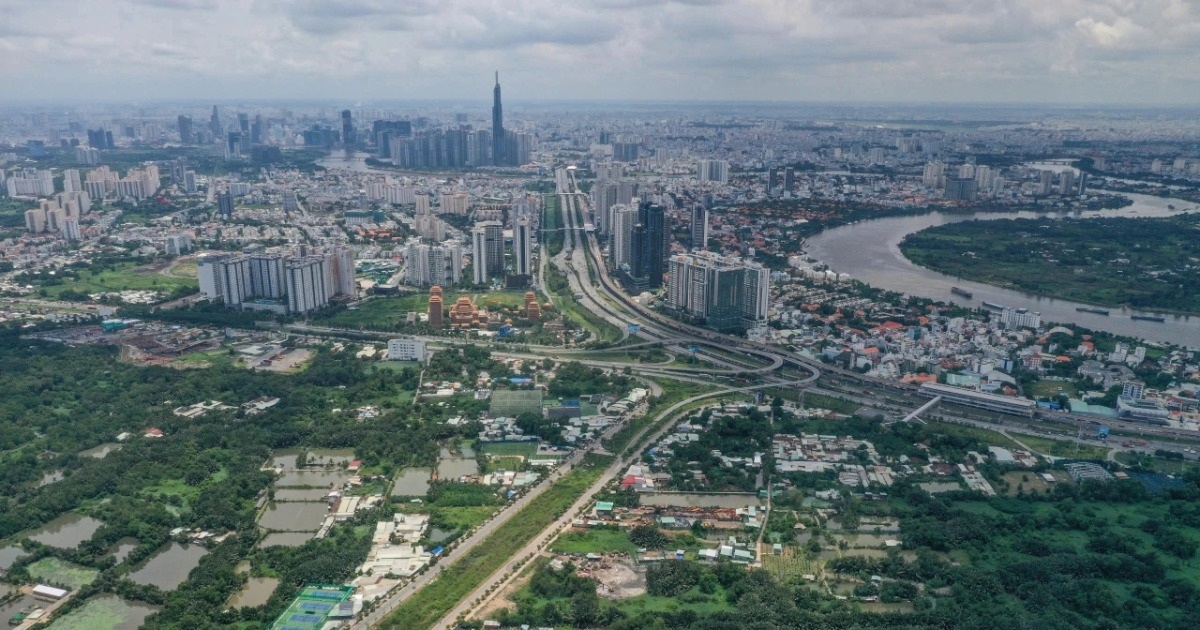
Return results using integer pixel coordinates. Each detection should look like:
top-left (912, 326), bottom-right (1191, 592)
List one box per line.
top-left (380, 453), bottom-right (604, 630)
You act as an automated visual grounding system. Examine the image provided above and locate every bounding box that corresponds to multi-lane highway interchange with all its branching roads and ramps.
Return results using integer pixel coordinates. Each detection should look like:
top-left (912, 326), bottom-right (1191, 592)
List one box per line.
top-left (338, 169), bottom-right (1196, 628)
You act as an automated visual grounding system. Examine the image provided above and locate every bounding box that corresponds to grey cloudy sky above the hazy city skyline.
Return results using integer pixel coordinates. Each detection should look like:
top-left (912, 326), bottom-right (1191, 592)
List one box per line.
top-left (0, 0), bottom-right (1200, 104)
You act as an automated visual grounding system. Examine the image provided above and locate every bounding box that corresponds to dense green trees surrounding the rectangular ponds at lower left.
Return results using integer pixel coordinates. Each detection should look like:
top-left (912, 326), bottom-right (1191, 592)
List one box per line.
top-left (0, 329), bottom-right (492, 628)
